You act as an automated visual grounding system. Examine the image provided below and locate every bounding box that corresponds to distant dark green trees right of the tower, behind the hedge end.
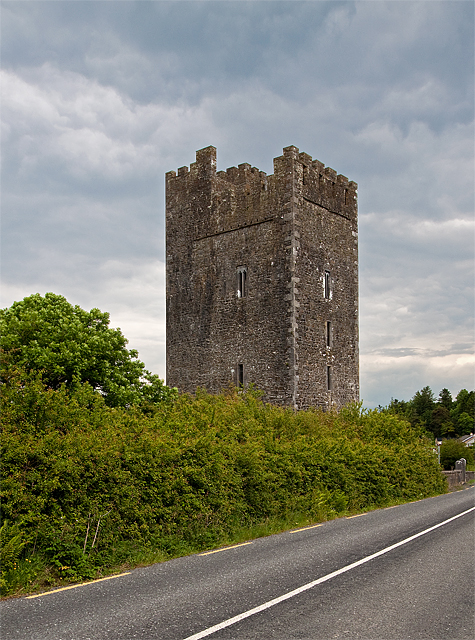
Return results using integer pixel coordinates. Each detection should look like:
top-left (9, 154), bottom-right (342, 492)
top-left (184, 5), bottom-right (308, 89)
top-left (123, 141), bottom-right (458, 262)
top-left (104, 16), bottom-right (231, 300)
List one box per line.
top-left (386, 387), bottom-right (475, 438)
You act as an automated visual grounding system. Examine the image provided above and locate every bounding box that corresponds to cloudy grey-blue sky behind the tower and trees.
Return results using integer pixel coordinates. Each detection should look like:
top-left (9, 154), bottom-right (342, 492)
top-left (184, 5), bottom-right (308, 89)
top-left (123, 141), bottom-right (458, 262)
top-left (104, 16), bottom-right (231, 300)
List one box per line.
top-left (0, 0), bottom-right (475, 407)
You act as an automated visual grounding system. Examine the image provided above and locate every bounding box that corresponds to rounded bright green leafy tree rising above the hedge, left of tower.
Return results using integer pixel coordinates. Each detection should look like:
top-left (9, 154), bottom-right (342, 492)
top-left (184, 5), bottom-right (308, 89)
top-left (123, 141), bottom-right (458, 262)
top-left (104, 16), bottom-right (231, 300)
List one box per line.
top-left (0, 293), bottom-right (175, 406)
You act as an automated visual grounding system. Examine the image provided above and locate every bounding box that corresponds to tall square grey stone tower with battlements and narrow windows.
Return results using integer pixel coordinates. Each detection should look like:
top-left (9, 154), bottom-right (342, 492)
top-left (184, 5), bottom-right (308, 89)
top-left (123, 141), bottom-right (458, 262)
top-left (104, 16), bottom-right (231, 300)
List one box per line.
top-left (166, 146), bottom-right (359, 409)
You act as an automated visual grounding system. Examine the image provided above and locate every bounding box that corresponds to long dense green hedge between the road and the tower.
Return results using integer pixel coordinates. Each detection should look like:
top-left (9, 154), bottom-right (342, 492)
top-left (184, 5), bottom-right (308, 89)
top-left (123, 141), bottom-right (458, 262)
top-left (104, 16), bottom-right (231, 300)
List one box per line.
top-left (0, 370), bottom-right (444, 593)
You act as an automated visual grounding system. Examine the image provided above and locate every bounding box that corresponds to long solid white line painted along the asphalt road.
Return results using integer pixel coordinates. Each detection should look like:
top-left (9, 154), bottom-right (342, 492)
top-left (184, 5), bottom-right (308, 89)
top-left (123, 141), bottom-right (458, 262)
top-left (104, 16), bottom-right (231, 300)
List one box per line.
top-left (184, 507), bottom-right (475, 640)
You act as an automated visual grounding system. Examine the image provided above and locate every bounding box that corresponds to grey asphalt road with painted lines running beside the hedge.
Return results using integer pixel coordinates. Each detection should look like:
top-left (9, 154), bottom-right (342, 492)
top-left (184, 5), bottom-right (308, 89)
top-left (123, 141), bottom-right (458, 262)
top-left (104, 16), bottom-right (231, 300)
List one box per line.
top-left (0, 488), bottom-right (475, 640)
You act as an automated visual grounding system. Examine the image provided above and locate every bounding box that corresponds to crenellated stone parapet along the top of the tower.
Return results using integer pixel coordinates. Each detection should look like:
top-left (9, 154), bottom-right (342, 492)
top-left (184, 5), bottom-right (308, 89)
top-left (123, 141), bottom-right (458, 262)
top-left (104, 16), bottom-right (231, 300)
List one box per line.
top-left (166, 145), bottom-right (357, 238)
